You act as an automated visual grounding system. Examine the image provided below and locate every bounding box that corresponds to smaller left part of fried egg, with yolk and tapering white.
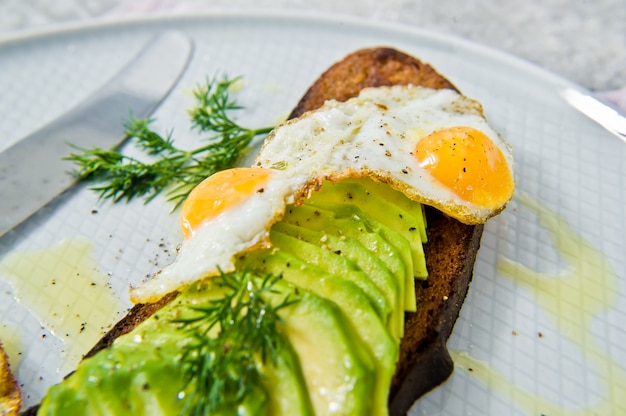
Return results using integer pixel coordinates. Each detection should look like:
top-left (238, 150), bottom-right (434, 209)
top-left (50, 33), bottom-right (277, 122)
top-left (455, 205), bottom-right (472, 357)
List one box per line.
top-left (131, 167), bottom-right (302, 303)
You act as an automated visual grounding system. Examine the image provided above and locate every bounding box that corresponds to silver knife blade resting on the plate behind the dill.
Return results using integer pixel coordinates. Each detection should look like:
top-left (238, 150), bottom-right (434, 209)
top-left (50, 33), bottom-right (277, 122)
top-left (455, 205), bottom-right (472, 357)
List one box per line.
top-left (0, 31), bottom-right (193, 237)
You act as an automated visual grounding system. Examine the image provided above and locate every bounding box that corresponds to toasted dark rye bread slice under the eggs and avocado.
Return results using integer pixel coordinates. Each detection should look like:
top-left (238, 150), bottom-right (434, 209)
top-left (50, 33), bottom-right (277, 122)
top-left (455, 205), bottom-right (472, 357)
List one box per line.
top-left (28, 48), bottom-right (483, 415)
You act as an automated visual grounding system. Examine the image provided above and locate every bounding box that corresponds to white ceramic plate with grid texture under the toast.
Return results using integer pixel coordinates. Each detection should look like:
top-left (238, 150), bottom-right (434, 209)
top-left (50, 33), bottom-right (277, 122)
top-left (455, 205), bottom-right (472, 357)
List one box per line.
top-left (0, 14), bottom-right (626, 415)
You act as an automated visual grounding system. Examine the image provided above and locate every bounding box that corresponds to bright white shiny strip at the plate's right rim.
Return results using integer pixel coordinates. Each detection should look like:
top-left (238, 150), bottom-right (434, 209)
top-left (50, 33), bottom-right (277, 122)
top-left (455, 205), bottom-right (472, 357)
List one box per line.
top-left (561, 88), bottom-right (626, 142)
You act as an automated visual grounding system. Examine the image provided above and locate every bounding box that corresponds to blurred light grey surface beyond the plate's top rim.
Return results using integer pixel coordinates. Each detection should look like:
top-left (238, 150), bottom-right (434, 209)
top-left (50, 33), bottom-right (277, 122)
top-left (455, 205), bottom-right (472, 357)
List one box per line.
top-left (0, 0), bottom-right (626, 91)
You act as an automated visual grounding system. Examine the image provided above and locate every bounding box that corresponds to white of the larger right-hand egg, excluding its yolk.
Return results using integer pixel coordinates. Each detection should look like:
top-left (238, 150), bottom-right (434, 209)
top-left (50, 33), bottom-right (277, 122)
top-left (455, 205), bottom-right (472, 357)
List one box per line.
top-left (255, 86), bottom-right (512, 224)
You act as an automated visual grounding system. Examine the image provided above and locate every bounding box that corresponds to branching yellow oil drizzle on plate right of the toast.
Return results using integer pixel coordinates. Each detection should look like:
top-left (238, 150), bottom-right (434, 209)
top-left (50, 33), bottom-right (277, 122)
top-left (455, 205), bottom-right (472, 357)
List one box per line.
top-left (451, 194), bottom-right (626, 416)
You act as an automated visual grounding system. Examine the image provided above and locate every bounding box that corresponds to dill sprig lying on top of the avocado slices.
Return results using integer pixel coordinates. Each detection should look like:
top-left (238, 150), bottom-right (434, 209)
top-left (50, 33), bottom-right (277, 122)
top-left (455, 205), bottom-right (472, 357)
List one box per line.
top-left (174, 271), bottom-right (297, 415)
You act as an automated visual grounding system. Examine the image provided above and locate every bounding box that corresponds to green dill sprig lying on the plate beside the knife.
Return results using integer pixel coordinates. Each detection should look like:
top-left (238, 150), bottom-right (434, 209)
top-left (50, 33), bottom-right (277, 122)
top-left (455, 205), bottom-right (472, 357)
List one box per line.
top-left (67, 77), bottom-right (273, 206)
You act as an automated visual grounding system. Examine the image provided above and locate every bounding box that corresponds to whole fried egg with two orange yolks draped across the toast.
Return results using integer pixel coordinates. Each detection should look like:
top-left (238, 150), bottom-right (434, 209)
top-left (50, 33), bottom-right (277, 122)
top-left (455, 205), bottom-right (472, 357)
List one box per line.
top-left (131, 86), bottom-right (514, 302)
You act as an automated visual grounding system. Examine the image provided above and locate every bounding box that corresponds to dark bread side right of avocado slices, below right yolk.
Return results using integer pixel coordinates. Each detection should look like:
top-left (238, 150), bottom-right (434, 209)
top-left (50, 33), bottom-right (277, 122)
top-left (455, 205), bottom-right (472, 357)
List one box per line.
top-left (389, 210), bottom-right (484, 415)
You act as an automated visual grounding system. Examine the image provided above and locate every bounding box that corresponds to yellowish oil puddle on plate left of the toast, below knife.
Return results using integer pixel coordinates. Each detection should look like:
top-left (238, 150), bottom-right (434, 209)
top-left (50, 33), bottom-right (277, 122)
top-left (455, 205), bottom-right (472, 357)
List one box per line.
top-left (0, 239), bottom-right (124, 375)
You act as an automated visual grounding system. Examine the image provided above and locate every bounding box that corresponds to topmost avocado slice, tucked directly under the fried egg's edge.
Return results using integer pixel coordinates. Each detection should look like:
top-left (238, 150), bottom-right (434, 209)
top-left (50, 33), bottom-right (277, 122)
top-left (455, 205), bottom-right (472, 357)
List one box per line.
top-left (307, 181), bottom-right (428, 278)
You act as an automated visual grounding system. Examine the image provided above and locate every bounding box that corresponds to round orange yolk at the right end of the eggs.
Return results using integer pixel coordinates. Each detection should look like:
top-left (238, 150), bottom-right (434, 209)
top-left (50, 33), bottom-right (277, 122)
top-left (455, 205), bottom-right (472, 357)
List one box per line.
top-left (415, 127), bottom-right (514, 208)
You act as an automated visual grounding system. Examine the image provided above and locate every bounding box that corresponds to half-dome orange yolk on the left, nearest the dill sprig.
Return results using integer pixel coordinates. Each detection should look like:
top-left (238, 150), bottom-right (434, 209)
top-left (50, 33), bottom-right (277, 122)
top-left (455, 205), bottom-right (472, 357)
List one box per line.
top-left (180, 168), bottom-right (272, 238)
